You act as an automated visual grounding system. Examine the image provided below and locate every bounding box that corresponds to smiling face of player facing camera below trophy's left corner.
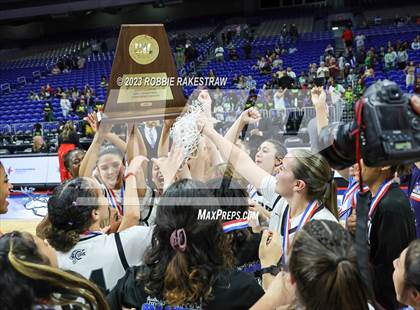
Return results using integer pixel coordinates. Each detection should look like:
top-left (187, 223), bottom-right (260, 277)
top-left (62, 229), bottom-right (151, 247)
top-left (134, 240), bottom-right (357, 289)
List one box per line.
top-left (98, 154), bottom-right (124, 189)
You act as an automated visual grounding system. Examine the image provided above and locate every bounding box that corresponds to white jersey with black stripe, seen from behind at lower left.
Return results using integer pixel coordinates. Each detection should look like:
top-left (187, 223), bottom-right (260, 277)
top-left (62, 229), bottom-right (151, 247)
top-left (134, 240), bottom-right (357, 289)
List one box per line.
top-left (57, 226), bottom-right (153, 291)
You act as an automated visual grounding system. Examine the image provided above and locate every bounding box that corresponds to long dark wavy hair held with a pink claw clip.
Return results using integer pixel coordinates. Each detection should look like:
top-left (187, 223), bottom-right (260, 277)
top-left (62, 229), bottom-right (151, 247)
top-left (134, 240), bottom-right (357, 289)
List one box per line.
top-left (138, 179), bottom-right (233, 305)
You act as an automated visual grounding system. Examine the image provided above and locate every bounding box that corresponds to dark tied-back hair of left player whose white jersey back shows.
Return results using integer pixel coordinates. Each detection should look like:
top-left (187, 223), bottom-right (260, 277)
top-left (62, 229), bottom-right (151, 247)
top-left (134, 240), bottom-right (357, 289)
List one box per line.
top-left (45, 178), bottom-right (99, 252)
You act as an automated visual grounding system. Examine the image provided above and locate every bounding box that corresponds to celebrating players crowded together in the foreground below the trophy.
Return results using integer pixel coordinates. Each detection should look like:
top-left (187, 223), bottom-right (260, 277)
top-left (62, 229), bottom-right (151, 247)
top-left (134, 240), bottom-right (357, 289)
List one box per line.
top-left (0, 87), bottom-right (420, 310)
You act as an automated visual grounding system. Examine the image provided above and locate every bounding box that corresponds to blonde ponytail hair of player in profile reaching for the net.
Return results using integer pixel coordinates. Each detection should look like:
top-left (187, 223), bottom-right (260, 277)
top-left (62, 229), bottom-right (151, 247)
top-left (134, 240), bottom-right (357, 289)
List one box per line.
top-left (290, 149), bottom-right (338, 217)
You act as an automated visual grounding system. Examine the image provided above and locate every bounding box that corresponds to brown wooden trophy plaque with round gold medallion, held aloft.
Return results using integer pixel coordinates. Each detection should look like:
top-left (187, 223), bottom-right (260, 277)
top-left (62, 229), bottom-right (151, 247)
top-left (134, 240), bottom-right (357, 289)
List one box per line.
top-left (100, 24), bottom-right (187, 122)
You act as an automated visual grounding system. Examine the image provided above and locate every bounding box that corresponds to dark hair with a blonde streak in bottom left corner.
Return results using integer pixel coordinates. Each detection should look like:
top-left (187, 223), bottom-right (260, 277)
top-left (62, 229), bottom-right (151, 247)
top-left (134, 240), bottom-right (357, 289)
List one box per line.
top-left (0, 231), bottom-right (109, 310)
